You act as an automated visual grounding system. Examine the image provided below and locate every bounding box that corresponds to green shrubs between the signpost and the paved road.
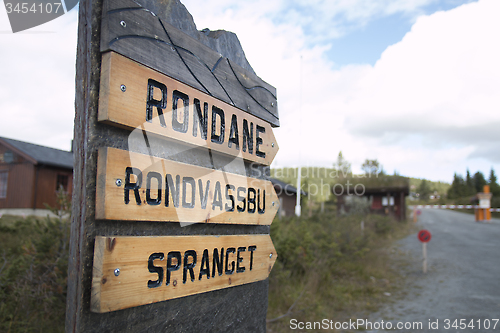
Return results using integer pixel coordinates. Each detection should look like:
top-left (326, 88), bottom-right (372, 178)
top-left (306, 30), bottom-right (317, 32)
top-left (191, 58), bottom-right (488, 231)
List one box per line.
top-left (267, 213), bottom-right (411, 332)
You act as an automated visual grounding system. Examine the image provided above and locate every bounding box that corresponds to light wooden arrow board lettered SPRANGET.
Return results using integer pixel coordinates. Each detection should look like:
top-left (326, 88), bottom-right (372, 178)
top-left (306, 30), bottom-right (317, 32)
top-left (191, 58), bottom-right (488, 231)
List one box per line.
top-left (91, 235), bottom-right (277, 312)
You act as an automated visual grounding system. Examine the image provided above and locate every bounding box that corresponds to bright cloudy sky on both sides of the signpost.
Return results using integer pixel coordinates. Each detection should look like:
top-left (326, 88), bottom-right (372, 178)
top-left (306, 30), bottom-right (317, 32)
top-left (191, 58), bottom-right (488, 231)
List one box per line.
top-left (0, 0), bottom-right (500, 182)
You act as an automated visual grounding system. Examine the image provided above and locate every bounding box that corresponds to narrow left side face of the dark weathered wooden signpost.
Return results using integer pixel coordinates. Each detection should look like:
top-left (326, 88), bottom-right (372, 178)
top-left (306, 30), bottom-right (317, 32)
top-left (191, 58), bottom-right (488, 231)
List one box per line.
top-left (65, 0), bottom-right (102, 333)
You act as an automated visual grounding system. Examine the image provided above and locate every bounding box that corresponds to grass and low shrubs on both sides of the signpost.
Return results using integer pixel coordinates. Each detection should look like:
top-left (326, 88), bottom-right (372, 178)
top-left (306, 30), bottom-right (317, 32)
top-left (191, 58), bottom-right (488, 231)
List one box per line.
top-left (0, 189), bottom-right (413, 333)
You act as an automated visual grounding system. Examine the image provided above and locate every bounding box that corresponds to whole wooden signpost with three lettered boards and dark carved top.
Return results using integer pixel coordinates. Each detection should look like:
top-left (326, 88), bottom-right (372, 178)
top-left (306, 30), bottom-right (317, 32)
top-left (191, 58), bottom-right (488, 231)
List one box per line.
top-left (66, 0), bottom-right (279, 332)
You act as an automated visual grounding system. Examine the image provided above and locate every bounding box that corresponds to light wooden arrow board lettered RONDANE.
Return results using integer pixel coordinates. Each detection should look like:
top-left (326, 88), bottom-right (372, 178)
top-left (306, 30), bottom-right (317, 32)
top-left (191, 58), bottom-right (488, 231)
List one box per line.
top-left (98, 52), bottom-right (278, 165)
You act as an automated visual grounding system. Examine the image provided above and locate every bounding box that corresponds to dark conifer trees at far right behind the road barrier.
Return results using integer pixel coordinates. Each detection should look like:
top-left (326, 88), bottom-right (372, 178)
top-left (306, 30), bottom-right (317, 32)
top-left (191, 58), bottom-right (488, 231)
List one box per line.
top-left (448, 168), bottom-right (500, 199)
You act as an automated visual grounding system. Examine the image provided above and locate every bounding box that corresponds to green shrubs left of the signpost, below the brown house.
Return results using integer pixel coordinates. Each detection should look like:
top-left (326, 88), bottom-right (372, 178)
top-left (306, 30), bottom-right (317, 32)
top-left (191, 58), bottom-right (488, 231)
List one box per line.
top-left (0, 191), bottom-right (69, 333)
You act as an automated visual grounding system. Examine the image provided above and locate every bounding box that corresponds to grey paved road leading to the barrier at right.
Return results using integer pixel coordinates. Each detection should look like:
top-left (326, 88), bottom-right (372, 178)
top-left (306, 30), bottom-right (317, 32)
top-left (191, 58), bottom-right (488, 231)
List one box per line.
top-left (368, 209), bottom-right (500, 333)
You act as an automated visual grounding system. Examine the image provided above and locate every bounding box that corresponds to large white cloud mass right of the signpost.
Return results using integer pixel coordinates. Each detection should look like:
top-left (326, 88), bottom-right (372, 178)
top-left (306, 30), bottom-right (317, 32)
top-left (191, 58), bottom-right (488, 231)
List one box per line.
top-left (186, 0), bottom-right (500, 180)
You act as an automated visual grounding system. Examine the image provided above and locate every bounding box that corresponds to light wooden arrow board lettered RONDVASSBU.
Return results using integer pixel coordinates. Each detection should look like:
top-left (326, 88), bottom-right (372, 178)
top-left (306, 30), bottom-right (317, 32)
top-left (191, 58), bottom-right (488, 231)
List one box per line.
top-left (96, 148), bottom-right (279, 225)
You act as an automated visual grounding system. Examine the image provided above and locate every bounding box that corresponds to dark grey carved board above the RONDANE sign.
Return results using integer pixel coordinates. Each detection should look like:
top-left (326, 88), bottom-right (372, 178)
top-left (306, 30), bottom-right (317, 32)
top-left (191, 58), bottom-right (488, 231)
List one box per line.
top-left (101, 0), bottom-right (279, 126)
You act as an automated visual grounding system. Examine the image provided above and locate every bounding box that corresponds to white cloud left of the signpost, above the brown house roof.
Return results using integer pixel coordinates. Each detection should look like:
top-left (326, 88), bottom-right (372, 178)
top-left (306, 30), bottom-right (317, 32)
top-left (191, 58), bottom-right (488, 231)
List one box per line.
top-left (0, 6), bottom-right (77, 150)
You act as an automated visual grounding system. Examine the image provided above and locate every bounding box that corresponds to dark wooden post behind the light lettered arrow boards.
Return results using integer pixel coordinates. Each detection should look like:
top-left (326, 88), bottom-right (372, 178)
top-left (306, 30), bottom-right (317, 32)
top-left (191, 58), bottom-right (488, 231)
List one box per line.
top-left (66, 0), bottom-right (277, 332)
